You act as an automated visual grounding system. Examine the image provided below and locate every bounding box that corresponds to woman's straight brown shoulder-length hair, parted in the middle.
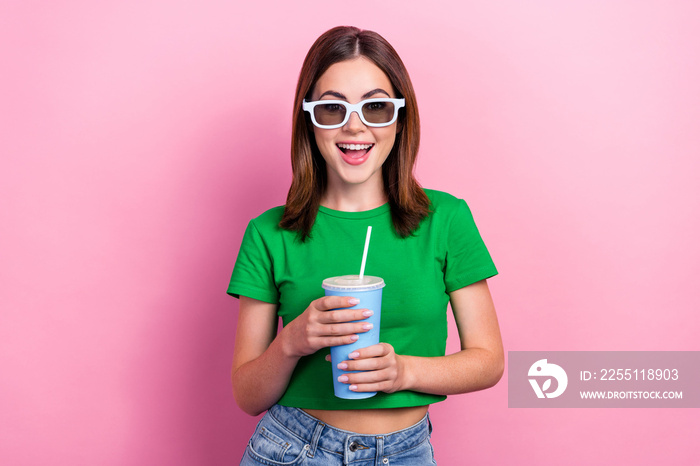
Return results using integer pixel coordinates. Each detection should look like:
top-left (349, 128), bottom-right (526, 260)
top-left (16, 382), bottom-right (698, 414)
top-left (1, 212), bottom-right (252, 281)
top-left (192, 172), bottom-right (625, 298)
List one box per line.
top-left (280, 26), bottom-right (430, 241)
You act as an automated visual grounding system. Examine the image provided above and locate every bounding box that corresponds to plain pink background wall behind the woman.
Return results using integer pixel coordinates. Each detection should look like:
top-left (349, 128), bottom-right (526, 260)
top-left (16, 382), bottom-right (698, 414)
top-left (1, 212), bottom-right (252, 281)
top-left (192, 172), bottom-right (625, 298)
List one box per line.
top-left (0, 0), bottom-right (700, 466)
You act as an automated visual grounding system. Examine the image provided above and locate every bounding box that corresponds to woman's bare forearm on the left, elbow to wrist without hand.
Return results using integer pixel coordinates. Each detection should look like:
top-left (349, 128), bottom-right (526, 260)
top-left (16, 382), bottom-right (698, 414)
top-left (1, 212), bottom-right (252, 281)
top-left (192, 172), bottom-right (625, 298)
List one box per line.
top-left (231, 330), bottom-right (299, 416)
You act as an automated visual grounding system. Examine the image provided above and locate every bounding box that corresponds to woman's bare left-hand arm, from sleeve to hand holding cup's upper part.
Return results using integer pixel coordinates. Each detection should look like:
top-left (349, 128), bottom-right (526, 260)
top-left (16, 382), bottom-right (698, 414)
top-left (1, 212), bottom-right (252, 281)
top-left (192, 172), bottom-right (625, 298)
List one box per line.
top-left (231, 296), bottom-right (371, 416)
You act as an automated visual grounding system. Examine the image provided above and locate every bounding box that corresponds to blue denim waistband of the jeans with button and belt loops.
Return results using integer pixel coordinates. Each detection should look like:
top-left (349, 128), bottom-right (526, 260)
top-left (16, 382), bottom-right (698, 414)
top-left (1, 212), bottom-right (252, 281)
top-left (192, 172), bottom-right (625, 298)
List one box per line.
top-left (268, 405), bottom-right (432, 460)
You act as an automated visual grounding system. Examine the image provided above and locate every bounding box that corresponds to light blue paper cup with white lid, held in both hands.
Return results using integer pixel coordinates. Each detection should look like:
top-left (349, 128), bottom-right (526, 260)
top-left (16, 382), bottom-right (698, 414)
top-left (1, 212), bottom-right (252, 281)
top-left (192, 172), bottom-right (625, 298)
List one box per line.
top-left (322, 275), bottom-right (384, 400)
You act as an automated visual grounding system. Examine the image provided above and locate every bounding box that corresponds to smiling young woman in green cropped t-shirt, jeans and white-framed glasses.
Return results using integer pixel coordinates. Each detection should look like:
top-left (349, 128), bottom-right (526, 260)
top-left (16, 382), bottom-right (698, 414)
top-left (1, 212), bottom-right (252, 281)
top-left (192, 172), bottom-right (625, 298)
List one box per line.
top-left (228, 27), bottom-right (503, 465)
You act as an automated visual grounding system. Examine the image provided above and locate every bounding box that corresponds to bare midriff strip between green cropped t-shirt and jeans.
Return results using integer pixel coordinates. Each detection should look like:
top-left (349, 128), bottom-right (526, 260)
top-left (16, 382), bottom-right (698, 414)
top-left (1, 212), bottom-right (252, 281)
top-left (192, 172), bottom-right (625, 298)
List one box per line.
top-left (304, 406), bottom-right (428, 435)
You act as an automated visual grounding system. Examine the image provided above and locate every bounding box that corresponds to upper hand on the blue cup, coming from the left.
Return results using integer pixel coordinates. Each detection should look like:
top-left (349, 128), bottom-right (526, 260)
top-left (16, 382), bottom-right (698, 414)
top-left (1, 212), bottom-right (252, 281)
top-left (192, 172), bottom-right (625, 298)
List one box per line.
top-left (283, 296), bottom-right (372, 357)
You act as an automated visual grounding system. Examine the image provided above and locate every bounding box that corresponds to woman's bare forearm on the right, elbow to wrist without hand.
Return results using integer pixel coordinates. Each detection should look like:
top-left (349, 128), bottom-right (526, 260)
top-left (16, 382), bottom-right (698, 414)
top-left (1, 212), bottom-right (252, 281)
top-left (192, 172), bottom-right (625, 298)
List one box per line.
top-left (398, 348), bottom-right (504, 395)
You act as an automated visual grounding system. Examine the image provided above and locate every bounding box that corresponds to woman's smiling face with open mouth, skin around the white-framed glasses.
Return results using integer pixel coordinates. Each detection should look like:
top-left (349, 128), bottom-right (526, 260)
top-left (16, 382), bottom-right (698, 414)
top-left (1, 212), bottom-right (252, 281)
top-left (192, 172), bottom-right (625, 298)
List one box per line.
top-left (311, 56), bottom-right (397, 193)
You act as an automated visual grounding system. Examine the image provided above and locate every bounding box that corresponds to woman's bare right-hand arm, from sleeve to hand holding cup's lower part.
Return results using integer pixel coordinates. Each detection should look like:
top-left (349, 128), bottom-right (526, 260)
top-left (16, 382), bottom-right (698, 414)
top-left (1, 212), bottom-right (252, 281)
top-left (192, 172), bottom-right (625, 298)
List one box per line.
top-left (334, 280), bottom-right (504, 395)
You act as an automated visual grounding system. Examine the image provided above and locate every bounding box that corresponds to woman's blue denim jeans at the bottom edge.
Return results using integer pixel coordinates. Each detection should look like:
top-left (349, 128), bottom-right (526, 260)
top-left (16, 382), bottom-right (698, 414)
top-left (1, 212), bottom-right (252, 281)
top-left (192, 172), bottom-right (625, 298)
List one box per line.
top-left (241, 405), bottom-right (437, 466)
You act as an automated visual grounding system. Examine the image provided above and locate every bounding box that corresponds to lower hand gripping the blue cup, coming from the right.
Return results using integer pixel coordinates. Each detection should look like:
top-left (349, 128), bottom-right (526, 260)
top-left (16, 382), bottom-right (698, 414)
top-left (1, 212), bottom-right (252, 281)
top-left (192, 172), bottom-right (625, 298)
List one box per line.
top-left (338, 343), bottom-right (407, 393)
